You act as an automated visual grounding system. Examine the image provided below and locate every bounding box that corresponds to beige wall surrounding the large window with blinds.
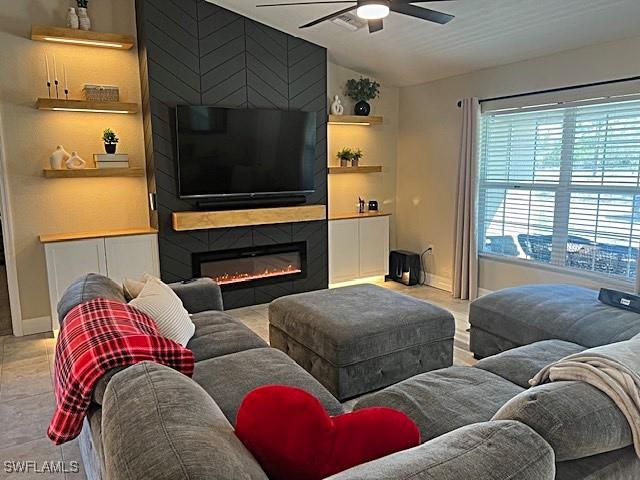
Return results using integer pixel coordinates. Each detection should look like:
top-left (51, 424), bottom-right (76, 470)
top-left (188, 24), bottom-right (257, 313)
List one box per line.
top-left (396, 37), bottom-right (640, 290)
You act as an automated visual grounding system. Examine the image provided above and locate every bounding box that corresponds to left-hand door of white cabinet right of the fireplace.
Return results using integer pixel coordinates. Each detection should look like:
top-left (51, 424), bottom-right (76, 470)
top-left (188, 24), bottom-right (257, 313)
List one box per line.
top-left (329, 220), bottom-right (359, 283)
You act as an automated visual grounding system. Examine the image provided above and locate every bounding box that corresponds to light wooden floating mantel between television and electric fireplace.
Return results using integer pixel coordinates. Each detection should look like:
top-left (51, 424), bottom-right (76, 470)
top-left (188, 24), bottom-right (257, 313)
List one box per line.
top-left (172, 205), bottom-right (327, 232)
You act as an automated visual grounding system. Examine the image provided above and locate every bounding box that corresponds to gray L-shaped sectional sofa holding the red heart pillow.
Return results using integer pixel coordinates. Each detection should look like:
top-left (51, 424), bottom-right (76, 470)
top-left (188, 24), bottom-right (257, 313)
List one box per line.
top-left (60, 275), bottom-right (640, 480)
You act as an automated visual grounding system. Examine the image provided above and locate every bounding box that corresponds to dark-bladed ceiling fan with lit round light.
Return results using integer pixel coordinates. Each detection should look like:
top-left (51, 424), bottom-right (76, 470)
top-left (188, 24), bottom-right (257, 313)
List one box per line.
top-left (256, 0), bottom-right (454, 33)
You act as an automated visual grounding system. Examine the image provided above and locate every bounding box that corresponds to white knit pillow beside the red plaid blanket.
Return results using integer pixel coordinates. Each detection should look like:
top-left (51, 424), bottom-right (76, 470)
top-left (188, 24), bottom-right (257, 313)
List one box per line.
top-left (129, 275), bottom-right (196, 347)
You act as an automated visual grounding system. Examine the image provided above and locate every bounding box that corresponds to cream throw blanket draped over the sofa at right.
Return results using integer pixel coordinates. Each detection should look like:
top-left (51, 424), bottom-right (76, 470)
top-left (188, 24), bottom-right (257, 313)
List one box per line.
top-left (529, 337), bottom-right (640, 457)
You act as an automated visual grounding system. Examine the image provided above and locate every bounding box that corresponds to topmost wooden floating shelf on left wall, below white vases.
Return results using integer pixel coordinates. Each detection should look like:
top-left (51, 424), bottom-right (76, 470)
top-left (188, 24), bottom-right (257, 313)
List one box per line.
top-left (31, 25), bottom-right (134, 50)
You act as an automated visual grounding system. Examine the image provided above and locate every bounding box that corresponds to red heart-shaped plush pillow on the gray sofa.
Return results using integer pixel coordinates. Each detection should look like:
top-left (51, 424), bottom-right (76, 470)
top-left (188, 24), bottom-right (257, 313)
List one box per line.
top-left (236, 385), bottom-right (420, 480)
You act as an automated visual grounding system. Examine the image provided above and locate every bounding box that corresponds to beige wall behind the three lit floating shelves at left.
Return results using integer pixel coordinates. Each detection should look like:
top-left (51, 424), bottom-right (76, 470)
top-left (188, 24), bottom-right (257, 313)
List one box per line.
top-left (0, 0), bottom-right (149, 332)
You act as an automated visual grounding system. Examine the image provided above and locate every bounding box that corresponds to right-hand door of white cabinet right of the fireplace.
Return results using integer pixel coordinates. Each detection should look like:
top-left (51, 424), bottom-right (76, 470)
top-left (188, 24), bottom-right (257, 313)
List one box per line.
top-left (359, 217), bottom-right (389, 277)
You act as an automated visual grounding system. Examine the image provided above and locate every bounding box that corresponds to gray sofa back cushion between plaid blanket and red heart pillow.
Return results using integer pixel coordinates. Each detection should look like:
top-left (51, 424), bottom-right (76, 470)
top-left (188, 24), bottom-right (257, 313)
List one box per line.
top-left (102, 362), bottom-right (267, 480)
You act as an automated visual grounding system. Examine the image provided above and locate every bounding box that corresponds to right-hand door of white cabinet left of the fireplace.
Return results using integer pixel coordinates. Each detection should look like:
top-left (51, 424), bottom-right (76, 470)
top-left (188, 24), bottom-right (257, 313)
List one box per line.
top-left (105, 234), bottom-right (160, 283)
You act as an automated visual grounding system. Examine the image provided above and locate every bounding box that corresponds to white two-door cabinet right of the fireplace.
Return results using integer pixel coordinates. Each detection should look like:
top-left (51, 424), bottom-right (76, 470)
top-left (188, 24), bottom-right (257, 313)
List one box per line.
top-left (329, 216), bottom-right (389, 284)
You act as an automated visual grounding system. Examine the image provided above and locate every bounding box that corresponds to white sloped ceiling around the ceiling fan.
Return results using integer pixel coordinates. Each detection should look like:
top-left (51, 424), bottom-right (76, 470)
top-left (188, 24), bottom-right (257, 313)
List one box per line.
top-left (208, 0), bottom-right (640, 86)
